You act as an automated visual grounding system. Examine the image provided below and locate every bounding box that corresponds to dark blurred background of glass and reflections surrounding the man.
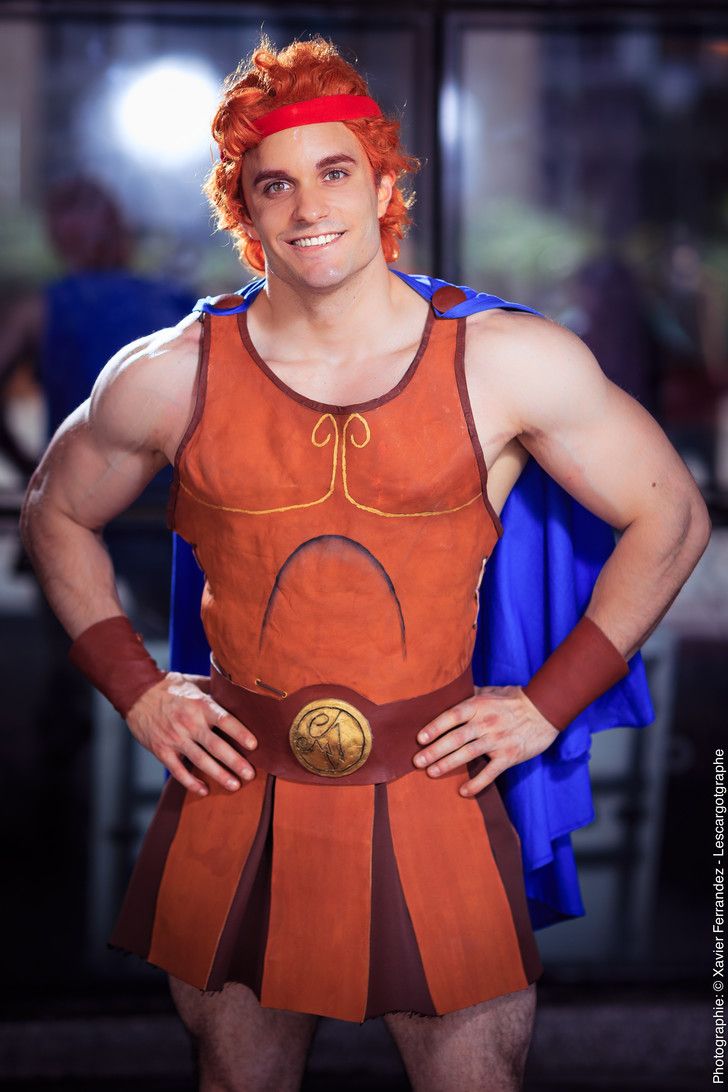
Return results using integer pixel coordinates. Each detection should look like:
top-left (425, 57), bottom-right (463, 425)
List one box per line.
top-left (0, 0), bottom-right (728, 1092)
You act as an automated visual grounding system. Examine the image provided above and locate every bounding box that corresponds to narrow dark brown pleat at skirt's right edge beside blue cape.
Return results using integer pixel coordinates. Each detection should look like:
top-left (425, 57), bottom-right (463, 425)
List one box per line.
top-left (467, 756), bottom-right (544, 982)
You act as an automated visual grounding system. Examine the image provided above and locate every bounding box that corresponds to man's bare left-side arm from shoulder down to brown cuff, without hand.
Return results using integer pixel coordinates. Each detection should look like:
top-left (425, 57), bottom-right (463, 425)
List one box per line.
top-left (21, 323), bottom-right (199, 638)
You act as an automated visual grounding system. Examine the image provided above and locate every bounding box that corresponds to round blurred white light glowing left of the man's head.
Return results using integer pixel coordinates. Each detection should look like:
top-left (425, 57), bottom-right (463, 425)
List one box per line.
top-left (111, 57), bottom-right (219, 167)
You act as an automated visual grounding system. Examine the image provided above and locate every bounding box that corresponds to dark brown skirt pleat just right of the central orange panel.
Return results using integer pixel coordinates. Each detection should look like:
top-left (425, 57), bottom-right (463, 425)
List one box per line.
top-left (365, 784), bottom-right (437, 1019)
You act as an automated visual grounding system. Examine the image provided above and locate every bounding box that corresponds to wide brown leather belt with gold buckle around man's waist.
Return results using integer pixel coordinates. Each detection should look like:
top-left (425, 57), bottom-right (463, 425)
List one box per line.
top-left (211, 658), bottom-right (475, 785)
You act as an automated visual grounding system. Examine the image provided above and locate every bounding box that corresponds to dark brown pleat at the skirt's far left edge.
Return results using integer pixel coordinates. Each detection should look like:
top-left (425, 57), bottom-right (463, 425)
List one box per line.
top-left (109, 778), bottom-right (187, 957)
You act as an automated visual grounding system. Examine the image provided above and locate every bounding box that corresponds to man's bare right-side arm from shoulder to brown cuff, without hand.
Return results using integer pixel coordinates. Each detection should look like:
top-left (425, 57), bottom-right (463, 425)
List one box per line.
top-left (484, 316), bottom-right (711, 658)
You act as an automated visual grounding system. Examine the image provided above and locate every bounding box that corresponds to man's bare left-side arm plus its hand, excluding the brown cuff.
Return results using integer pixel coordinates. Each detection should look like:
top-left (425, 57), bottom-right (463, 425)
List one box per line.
top-left (21, 320), bottom-right (255, 796)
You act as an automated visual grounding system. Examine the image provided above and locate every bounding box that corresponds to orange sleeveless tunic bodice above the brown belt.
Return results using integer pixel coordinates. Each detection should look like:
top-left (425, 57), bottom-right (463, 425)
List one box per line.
top-left (169, 303), bottom-right (501, 702)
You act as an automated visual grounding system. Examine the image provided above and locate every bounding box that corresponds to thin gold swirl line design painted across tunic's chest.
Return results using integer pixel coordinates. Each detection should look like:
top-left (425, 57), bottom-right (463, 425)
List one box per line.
top-left (179, 413), bottom-right (482, 519)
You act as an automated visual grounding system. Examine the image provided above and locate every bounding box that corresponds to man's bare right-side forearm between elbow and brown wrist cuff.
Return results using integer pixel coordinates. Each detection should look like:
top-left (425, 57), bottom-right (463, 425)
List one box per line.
top-left (586, 497), bottom-right (711, 660)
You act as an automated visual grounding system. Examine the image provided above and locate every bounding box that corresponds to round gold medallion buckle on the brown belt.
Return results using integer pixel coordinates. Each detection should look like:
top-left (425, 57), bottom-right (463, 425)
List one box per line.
top-left (288, 698), bottom-right (372, 778)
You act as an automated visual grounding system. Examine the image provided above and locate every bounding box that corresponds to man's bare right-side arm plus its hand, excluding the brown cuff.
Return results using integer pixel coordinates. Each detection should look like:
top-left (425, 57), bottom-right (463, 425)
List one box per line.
top-left (414, 314), bottom-right (711, 795)
